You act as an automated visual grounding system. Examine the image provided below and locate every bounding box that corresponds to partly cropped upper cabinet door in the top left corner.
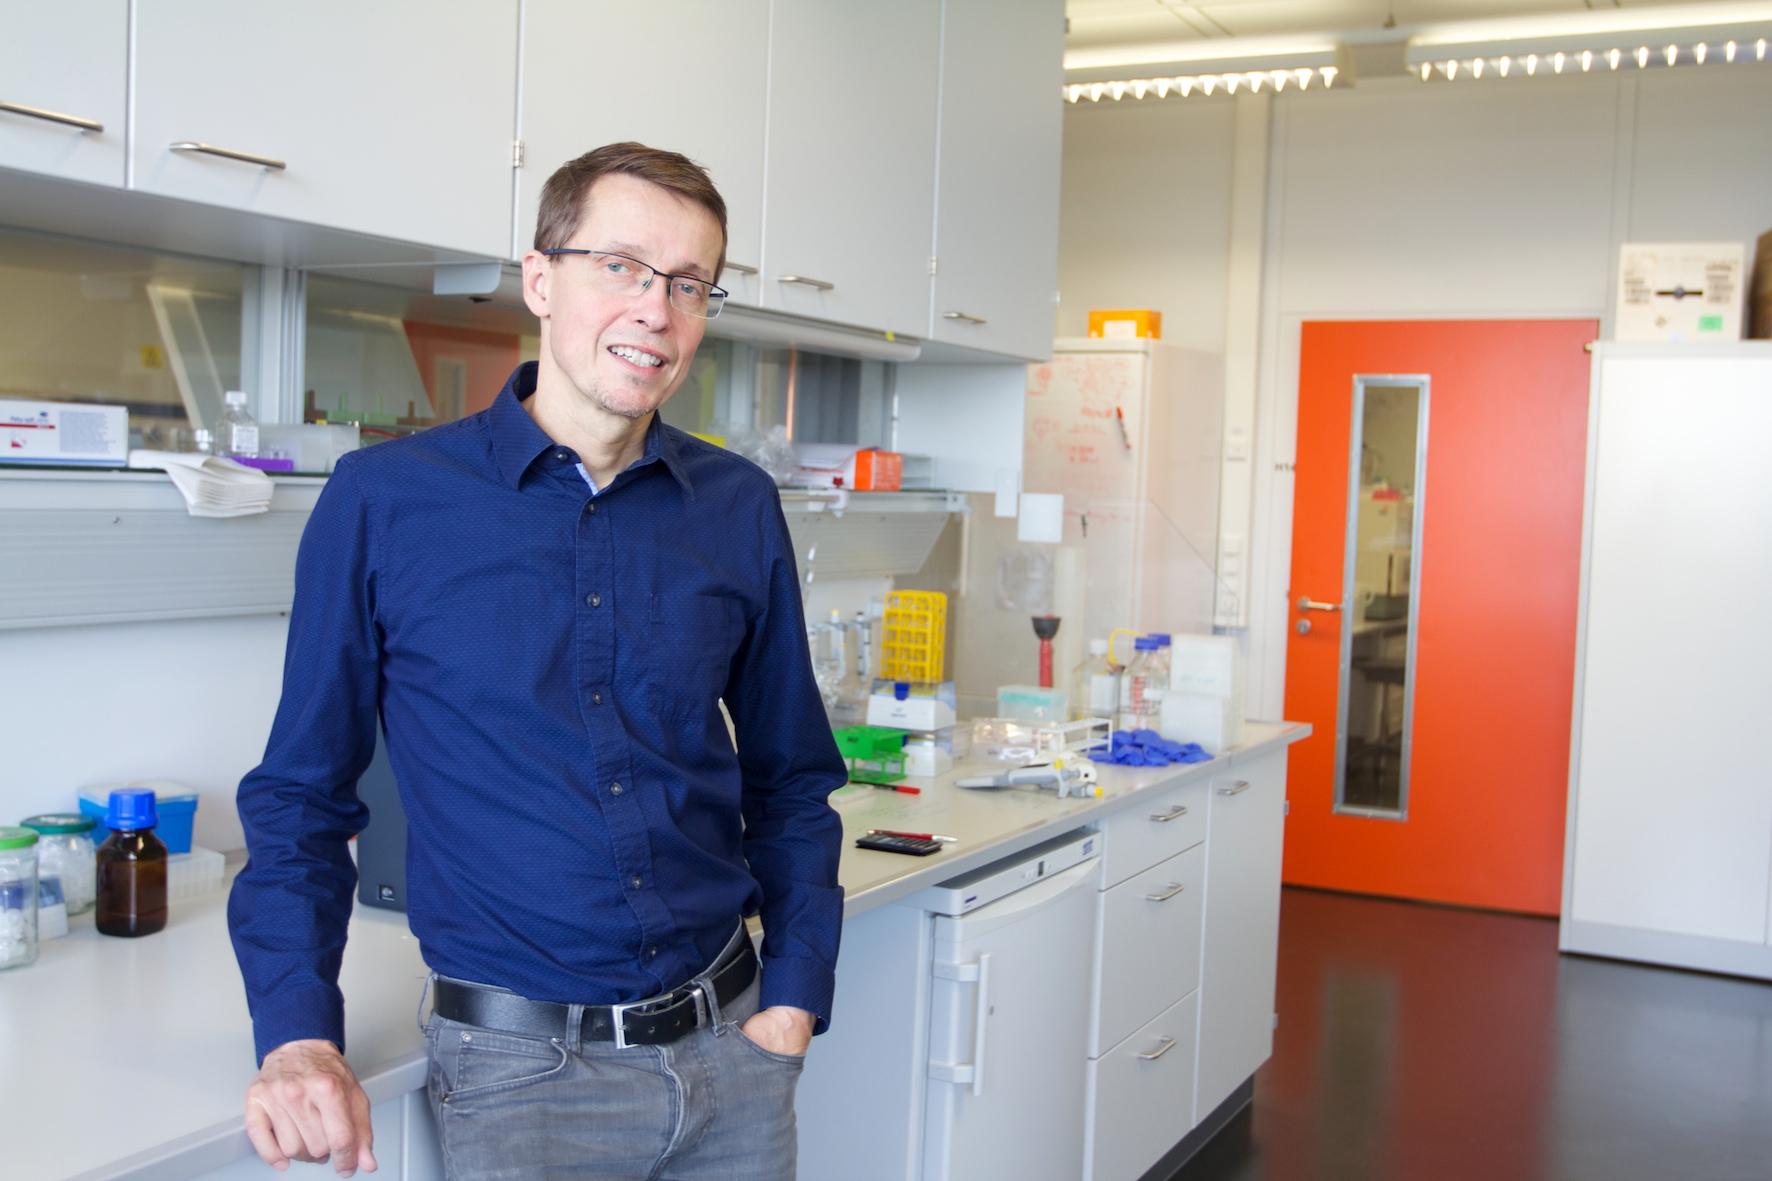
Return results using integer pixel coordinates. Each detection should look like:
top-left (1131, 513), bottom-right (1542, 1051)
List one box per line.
top-left (0, 0), bottom-right (129, 186)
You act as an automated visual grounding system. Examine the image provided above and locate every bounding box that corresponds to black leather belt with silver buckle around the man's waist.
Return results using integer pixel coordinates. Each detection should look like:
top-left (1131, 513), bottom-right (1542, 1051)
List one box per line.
top-left (432, 927), bottom-right (757, 1048)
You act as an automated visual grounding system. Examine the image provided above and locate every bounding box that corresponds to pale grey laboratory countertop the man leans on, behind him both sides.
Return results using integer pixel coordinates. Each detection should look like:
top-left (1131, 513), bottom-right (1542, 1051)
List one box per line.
top-left (10, 722), bottom-right (1310, 1181)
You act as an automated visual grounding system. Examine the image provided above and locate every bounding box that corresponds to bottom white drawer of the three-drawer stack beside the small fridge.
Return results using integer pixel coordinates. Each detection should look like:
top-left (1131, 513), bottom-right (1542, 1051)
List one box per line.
top-left (1083, 991), bottom-right (1200, 1181)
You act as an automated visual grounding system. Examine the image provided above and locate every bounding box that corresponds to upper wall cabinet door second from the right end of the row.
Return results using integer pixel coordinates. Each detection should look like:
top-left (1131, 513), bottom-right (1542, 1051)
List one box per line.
top-left (762, 0), bottom-right (941, 335)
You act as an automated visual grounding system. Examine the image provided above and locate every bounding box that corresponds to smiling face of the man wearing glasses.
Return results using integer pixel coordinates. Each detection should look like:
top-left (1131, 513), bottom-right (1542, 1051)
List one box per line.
top-left (523, 174), bottom-right (719, 418)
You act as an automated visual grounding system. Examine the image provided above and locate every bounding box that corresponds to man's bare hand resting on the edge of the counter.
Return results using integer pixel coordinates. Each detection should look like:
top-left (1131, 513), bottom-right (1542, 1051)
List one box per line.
top-left (246, 1035), bottom-right (375, 1177)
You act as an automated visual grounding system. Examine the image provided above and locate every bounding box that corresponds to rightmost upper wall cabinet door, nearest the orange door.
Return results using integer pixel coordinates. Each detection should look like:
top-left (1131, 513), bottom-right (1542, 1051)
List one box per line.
top-left (929, 0), bottom-right (1065, 360)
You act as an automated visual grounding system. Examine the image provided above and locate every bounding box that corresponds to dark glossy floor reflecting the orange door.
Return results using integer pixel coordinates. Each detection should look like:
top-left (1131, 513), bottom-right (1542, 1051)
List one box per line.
top-left (1175, 888), bottom-right (1772, 1181)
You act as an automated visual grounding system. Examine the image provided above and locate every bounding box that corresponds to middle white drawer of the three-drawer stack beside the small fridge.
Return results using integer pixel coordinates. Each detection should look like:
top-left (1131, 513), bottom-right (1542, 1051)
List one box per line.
top-left (1090, 844), bottom-right (1207, 1057)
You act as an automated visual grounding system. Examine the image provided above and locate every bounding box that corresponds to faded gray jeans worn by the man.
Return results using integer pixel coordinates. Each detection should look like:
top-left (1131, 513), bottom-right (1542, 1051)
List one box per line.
top-left (425, 977), bottom-right (803, 1181)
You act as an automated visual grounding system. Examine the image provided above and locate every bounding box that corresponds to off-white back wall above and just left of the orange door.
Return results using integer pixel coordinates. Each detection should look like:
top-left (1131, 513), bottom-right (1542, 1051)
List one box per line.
top-left (1060, 66), bottom-right (1772, 718)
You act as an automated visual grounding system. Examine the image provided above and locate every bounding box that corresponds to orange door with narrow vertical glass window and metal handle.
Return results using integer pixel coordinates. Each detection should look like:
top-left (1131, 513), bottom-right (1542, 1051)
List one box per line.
top-left (1285, 321), bottom-right (1598, 915)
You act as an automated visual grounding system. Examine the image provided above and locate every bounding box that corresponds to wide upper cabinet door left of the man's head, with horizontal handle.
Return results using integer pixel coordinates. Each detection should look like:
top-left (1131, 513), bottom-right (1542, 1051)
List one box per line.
top-left (131, 0), bottom-right (517, 257)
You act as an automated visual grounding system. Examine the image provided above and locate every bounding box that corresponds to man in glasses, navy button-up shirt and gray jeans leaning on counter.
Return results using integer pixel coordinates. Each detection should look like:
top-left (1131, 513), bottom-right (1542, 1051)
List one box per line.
top-left (229, 144), bottom-right (845, 1181)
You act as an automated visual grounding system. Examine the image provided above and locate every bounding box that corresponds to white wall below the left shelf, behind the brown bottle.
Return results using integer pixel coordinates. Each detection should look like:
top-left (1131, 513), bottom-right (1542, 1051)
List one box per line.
top-left (0, 615), bottom-right (289, 851)
